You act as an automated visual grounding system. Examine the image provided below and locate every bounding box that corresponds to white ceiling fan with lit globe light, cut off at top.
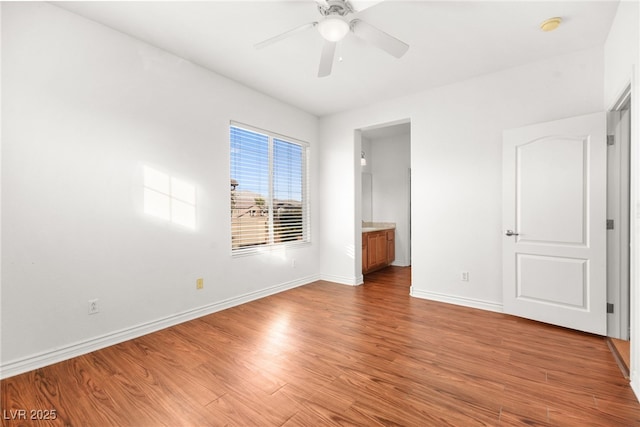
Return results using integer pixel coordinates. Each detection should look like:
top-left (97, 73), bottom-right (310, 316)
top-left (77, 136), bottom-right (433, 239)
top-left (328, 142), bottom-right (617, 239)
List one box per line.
top-left (255, 0), bottom-right (409, 77)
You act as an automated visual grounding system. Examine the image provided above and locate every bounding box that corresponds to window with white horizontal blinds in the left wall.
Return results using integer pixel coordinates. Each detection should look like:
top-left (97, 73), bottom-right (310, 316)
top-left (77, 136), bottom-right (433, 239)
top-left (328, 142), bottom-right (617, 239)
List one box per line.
top-left (230, 124), bottom-right (309, 253)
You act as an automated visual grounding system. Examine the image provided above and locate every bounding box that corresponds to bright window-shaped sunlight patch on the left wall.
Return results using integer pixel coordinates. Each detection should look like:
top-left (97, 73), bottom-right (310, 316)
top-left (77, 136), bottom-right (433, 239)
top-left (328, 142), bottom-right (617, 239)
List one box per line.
top-left (144, 166), bottom-right (196, 229)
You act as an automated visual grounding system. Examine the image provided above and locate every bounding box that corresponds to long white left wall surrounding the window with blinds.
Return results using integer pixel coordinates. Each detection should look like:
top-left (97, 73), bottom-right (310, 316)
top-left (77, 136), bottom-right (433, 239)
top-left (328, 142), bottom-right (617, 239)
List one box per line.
top-left (0, 2), bottom-right (319, 376)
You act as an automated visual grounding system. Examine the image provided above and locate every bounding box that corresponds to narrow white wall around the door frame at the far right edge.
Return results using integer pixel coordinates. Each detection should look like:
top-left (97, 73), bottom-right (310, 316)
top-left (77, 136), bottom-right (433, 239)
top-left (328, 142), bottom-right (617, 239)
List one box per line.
top-left (603, 1), bottom-right (640, 402)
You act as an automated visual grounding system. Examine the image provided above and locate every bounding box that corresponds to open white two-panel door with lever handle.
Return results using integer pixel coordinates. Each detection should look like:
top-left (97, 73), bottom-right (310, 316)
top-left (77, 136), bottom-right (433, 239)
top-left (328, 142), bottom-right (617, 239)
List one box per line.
top-left (502, 113), bottom-right (607, 335)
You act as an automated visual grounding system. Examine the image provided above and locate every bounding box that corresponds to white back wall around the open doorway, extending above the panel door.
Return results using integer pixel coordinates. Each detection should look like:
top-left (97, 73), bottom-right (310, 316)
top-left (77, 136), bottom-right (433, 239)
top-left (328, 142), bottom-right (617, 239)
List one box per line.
top-left (320, 48), bottom-right (603, 310)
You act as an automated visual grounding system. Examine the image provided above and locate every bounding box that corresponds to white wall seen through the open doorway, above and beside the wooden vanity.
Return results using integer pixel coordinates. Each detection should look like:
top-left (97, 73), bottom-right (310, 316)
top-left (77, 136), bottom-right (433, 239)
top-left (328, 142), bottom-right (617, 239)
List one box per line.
top-left (369, 134), bottom-right (411, 266)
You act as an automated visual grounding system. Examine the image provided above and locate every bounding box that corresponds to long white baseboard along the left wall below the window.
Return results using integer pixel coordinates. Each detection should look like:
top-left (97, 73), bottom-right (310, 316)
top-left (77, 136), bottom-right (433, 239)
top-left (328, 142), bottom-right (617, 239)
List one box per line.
top-left (0, 275), bottom-right (320, 379)
